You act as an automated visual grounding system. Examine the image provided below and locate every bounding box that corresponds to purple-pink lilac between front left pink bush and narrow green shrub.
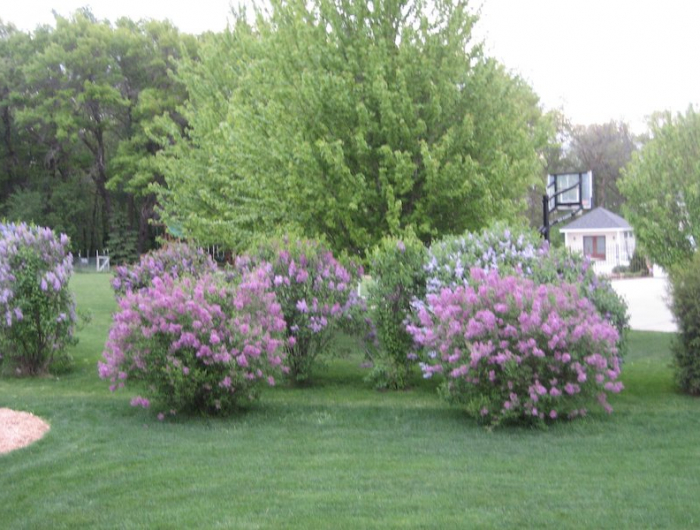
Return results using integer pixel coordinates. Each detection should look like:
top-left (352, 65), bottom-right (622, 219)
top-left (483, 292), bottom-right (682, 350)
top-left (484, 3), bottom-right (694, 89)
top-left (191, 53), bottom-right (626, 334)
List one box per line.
top-left (236, 238), bottom-right (365, 383)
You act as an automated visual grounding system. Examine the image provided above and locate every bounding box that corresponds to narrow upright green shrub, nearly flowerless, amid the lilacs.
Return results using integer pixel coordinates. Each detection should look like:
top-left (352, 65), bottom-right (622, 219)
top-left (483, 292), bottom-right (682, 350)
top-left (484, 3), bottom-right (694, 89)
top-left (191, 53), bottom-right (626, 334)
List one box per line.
top-left (368, 236), bottom-right (427, 388)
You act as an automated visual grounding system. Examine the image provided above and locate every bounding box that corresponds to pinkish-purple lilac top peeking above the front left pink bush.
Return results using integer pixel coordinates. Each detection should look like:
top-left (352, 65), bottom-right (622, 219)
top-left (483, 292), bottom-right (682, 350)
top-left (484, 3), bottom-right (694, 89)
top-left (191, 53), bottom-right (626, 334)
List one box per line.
top-left (112, 243), bottom-right (216, 298)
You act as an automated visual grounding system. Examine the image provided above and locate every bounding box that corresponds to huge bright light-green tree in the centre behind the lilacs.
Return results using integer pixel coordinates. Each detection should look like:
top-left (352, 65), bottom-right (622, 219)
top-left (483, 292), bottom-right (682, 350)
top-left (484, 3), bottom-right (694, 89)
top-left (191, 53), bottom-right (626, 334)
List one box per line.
top-left (162, 0), bottom-right (548, 253)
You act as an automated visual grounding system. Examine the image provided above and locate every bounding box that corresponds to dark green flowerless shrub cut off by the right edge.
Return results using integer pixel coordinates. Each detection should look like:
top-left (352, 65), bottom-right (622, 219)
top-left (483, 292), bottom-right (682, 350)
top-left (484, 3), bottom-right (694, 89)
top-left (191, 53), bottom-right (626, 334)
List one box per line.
top-left (670, 253), bottom-right (700, 396)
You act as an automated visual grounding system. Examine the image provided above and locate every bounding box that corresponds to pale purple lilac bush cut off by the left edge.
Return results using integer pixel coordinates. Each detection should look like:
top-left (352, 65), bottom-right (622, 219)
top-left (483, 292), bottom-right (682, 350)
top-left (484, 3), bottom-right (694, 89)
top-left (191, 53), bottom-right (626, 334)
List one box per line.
top-left (0, 223), bottom-right (77, 375)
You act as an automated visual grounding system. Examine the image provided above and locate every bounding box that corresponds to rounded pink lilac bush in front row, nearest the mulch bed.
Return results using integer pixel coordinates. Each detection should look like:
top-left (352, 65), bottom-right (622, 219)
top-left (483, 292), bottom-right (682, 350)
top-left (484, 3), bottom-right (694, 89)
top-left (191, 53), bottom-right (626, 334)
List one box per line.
top-left (99, 266), bottom-right (285, 413)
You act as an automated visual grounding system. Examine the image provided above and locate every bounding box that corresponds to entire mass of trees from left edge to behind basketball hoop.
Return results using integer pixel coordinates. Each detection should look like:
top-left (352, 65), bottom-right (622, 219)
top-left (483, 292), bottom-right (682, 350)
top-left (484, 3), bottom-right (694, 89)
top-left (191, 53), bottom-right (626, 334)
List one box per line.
top-left (0, 0), bottom-right (638, 260)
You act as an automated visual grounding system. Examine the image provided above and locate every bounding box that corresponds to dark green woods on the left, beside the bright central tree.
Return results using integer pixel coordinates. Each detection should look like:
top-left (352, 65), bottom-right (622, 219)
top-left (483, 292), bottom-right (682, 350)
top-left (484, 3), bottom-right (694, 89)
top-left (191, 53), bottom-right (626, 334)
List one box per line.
top-left (0, 9), bottom-right (197, 258)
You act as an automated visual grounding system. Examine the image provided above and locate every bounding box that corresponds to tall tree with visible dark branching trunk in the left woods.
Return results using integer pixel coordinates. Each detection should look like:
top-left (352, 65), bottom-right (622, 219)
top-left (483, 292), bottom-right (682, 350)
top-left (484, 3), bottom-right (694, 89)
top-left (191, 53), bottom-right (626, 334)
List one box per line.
top-left (18, 10), bottom-right (127, 233)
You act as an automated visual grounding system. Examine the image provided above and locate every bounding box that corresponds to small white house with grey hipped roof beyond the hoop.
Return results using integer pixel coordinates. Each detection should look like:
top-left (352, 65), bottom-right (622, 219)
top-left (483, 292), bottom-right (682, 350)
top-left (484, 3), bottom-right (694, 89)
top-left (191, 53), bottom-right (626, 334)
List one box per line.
top-left (559, 208), bottom-right (635, 274)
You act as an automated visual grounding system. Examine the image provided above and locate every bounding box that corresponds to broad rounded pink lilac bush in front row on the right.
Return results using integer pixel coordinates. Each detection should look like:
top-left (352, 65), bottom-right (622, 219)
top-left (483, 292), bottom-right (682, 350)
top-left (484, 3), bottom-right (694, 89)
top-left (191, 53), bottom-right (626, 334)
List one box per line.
top-left (407, 268), bottom-right (622, 425)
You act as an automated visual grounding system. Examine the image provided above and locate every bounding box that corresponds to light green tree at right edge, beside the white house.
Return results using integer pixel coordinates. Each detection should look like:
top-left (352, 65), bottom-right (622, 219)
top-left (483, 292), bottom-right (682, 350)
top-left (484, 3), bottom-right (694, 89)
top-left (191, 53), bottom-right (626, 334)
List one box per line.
top-left (619, 107), bottom-right (700, 267)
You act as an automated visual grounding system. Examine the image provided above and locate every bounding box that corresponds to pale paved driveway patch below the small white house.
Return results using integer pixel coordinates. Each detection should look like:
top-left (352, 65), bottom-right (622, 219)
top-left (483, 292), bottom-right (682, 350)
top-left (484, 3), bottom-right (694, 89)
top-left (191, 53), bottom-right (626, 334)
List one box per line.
top-left (611, 278), bottom-right (678, 332)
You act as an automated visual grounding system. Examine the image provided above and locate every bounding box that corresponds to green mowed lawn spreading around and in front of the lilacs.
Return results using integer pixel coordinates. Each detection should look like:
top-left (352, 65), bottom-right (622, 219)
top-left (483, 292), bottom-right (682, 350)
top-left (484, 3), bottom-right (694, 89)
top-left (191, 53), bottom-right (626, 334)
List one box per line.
top-left (0, 274), bottom-right (700, 529)
